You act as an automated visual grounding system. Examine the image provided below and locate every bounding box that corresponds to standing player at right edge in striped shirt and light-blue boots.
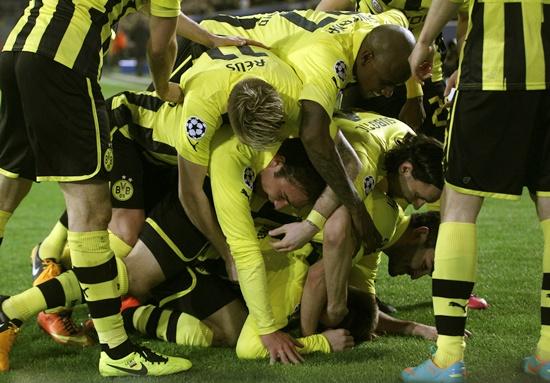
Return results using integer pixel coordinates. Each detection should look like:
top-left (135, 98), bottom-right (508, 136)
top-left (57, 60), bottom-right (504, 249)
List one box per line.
top-left (401, 0), bottom-right (550, 382)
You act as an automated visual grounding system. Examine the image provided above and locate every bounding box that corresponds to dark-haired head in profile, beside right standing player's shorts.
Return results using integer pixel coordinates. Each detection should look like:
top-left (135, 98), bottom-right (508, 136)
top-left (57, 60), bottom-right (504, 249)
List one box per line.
top-left (384, 134), bottom-right (443, 209)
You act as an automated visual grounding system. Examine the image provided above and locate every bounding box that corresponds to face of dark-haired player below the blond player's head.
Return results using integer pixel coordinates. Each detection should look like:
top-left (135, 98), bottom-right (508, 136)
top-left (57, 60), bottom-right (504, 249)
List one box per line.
top-left (260, 163), bottom-right (309, 210)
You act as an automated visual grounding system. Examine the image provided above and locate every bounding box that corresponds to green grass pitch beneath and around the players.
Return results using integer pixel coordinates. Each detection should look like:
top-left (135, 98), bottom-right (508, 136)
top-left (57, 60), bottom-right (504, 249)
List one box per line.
top-left (0, 80), bottom-right (542, 383)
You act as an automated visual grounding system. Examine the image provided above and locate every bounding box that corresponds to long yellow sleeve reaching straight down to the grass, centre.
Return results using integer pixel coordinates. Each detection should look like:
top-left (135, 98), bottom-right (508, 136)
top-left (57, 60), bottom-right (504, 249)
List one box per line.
top-left (210, 139), bottom-right (277, 335)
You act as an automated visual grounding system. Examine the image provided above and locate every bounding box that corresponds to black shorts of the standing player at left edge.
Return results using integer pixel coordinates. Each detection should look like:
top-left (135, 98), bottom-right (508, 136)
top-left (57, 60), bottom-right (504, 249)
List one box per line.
top-left (0, 52), bottom-right (113, 182)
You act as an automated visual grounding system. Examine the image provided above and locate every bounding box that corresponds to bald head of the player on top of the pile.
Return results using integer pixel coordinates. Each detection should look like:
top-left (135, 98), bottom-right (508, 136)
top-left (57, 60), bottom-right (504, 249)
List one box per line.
top-left (354, 24), bottom-right (415, 97)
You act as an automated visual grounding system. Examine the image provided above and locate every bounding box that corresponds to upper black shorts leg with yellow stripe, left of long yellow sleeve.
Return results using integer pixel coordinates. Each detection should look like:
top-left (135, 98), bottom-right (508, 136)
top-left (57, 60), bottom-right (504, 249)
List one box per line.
top-left (139, 192), bottom-right (209, 280)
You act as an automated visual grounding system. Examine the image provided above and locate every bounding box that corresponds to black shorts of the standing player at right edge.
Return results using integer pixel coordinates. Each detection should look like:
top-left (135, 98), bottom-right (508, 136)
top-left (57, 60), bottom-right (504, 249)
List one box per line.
top-left (445, 90), bottom-right (550, 199)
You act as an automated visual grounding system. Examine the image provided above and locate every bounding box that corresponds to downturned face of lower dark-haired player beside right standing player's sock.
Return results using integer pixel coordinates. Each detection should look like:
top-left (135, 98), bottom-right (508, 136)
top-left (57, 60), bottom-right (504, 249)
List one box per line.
top-left (388, 245), bottom-right (435, 279)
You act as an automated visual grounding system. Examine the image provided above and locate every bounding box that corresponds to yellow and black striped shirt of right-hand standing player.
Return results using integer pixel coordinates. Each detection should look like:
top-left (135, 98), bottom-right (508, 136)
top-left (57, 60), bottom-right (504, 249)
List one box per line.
top-left (459, 0), bottom-right (550, 91)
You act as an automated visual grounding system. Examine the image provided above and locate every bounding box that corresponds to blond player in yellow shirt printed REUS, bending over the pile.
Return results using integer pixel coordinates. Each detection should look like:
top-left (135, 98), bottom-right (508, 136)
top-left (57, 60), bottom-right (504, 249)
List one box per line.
top-left (29, 46), bottom-right (301, 348)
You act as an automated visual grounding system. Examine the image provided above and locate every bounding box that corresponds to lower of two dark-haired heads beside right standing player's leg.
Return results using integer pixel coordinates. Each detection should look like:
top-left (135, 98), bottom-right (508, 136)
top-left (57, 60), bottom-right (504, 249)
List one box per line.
top-left (384, 211), bottom-right (440, 279)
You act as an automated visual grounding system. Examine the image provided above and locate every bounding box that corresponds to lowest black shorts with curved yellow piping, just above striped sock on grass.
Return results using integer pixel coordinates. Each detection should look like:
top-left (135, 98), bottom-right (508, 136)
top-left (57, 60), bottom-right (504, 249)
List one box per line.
top-left (152, 261), bottom-right (242, 320)
